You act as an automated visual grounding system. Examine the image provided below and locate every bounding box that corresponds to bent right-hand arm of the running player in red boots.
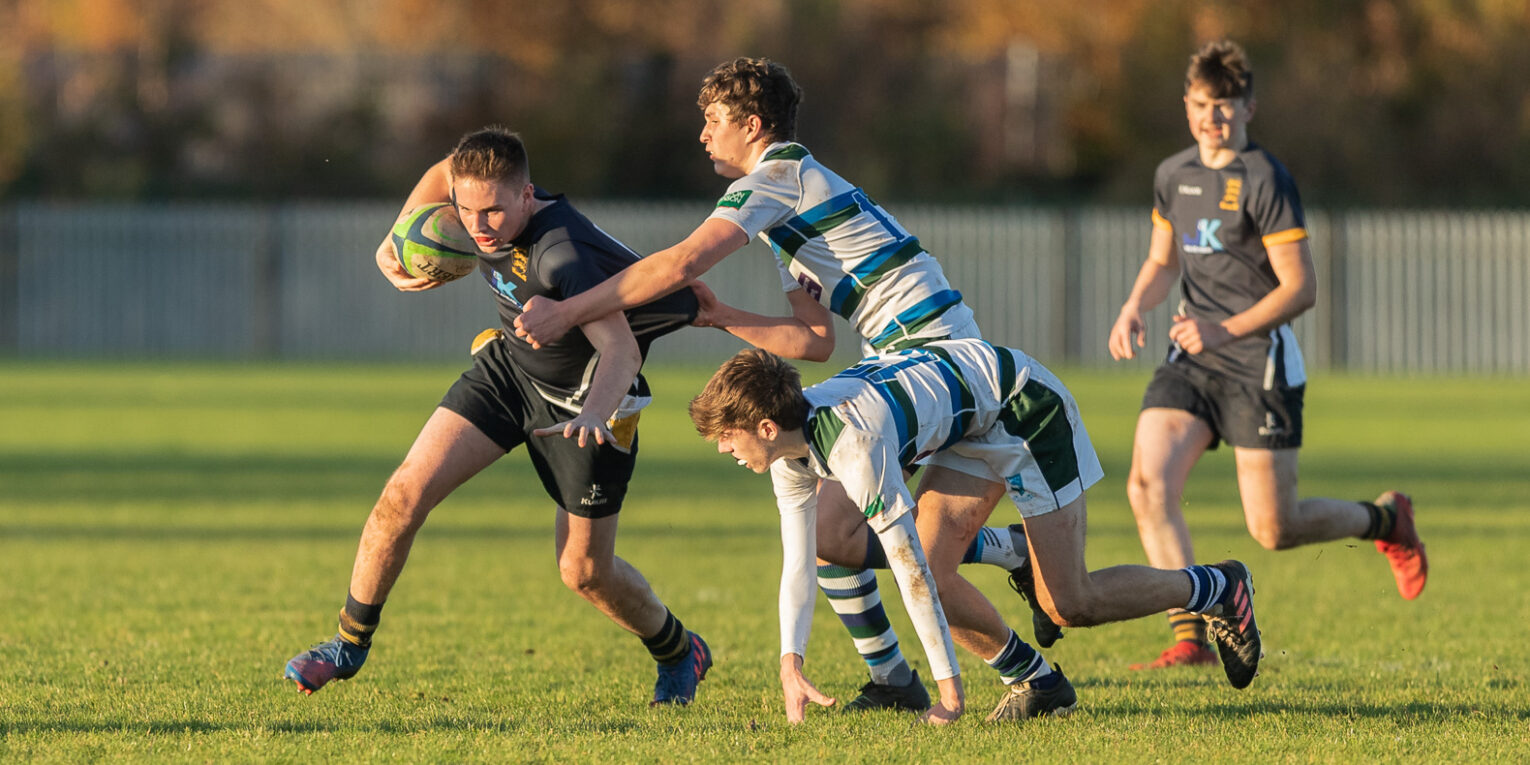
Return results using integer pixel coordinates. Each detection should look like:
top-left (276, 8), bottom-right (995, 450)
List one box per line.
top-left (1169, 239), bottom-right (1317, 353)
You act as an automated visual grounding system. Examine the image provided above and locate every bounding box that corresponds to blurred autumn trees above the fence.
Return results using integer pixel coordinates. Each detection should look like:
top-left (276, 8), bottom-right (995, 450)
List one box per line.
top-left (0, 0), bottom-right (1530, 205)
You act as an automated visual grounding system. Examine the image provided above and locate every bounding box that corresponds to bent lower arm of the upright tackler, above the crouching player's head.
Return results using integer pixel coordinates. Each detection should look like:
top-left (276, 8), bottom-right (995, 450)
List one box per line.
top-left (690, 282), bottom-right (834, 361)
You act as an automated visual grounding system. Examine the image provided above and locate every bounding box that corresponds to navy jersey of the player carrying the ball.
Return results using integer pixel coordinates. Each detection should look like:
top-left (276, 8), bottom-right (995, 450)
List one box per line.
top-left (479, 188), bottom-right (698, 409)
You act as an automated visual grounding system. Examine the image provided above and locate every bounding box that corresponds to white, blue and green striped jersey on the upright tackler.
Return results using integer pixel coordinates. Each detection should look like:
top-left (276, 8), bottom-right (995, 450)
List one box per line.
top-left (710, 142), bottom-right (978, 350)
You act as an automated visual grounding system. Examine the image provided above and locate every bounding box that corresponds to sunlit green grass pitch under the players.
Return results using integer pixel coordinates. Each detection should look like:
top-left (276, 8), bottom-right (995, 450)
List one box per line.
top-left (0, 361), bottom-right (1530, 762)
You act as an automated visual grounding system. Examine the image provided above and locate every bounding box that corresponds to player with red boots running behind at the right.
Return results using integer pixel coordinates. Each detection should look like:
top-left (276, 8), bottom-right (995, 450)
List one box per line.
top-left (1109, 41), bottom-right (1429, 669)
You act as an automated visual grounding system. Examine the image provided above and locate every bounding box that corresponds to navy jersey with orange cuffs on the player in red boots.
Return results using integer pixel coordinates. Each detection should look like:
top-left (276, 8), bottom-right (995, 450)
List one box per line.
top-left (1152, 144), bottom-right (1307, 389)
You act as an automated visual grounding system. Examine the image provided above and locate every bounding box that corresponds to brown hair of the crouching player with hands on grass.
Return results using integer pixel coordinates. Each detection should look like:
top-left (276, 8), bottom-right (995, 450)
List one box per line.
top-left (690, 347), bottom-right (808, 441)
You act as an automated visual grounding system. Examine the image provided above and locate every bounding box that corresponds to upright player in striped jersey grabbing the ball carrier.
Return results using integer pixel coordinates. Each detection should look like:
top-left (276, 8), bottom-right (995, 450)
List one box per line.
top-left (516, 58), bottom-right (1060, 710)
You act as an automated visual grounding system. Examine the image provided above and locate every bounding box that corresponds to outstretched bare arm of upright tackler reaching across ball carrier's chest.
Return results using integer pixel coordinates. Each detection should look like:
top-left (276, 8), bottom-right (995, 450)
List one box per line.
top-left (516, 219), bottom-right (750, 347)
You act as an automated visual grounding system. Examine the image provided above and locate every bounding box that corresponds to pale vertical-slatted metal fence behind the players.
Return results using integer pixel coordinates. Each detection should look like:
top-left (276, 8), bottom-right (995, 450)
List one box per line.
top-left (0, 202), bottom-right (1530, 375)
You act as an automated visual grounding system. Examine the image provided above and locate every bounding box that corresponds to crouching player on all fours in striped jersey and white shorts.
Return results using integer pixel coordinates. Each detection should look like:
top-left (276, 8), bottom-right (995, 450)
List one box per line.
top-left (690, 340), bottom-right (1261, 721)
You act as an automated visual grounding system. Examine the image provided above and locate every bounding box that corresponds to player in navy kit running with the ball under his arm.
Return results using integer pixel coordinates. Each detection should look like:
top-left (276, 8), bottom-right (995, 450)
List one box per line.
top-left (285, 127), bottom-right (711, 705)
